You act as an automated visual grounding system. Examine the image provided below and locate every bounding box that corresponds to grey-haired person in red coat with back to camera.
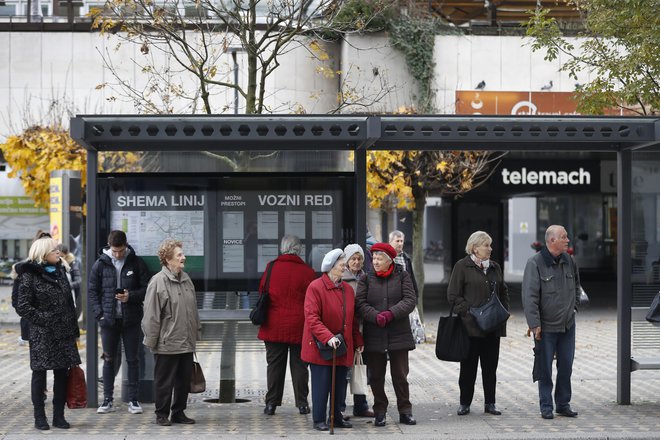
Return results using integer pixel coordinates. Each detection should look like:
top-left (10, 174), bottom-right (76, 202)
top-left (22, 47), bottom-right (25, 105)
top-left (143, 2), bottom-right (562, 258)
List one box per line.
top-left (258, 235), bottom-right (316, 416)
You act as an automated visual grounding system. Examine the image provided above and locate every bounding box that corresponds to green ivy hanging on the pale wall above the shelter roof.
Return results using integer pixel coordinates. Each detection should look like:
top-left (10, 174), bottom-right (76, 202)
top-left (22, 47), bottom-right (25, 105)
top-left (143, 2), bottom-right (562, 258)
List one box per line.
top-left (390, 15), bottom-right (438, 113)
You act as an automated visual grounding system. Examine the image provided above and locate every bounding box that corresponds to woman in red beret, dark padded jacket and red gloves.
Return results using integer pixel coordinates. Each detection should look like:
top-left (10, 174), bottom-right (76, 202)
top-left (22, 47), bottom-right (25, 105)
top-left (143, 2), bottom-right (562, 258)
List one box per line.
top-left (356, 243), bottom-right (417, 426)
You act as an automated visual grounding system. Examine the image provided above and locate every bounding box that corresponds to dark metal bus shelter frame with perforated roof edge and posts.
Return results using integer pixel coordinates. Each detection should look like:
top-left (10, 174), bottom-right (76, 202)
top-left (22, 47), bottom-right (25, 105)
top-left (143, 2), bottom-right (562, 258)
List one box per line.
top-left (71, 115), bottom-right (660, 405)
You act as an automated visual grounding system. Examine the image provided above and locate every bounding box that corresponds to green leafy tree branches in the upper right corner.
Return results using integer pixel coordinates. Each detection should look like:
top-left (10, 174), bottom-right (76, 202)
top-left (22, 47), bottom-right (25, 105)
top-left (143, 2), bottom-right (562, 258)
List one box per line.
top-left (527, 0), bottom-right (660, 115)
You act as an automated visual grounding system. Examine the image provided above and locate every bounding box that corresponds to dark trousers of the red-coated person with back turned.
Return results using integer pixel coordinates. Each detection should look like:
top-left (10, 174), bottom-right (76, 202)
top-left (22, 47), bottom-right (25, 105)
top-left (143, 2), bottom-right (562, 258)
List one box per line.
top-left (264, 341), bottom-right (309, 407)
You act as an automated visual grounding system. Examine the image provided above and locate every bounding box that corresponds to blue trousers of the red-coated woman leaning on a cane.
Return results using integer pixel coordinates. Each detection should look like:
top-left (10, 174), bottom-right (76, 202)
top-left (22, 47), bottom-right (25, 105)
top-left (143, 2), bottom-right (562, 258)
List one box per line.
top-left (309, 364), bottom-right (348, 423)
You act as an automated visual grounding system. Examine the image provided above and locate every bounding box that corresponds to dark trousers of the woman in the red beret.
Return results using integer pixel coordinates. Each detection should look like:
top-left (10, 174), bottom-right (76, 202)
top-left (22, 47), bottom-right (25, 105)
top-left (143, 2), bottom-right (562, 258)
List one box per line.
top-left (366, 350), bottom-right (412, 414)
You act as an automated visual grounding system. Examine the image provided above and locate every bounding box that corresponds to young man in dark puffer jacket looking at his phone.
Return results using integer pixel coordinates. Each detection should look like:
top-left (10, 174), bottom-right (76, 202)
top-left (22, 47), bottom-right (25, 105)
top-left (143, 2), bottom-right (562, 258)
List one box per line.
top-left (88, 231), bottom-right (149, 414)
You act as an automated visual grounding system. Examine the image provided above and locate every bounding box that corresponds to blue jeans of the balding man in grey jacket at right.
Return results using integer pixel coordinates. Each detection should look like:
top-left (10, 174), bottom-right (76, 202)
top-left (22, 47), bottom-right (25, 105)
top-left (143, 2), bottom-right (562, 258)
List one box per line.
top-left (536, 324), bottom-right (575, 411)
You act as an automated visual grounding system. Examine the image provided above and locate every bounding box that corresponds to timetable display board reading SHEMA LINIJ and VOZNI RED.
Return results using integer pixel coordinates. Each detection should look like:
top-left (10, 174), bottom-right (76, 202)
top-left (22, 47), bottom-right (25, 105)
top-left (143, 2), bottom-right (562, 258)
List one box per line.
top-left (98, 173), bottom-right (355, 291)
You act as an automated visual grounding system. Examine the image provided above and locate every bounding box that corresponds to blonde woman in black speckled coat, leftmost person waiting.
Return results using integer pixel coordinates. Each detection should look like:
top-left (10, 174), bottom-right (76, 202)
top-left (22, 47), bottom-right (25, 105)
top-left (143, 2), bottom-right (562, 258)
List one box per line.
top-left (16, 238), bottom-right (81, 430)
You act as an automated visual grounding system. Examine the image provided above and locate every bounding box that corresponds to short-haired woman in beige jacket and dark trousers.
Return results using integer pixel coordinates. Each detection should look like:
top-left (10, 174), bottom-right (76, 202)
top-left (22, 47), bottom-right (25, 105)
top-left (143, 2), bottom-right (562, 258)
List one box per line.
top-left (142, 239), bottom-right (202, 426)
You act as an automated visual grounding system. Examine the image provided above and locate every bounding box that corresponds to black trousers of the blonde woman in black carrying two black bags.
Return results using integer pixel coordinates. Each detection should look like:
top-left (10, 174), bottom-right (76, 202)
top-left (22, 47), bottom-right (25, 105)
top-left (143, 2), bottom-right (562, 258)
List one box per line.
top-left (458, 333), bottom-right (500, 405)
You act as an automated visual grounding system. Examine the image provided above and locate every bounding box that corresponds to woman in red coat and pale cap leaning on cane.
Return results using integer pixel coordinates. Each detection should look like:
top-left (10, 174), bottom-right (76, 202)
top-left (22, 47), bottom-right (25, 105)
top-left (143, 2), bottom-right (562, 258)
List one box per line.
top-left (302, 249), bottom-right (364, 431)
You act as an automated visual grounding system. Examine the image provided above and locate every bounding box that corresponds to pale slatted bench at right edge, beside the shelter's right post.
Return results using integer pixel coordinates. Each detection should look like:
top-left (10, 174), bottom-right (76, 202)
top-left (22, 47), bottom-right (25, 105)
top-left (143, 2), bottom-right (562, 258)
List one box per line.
top-left (630, 307), bottom-right (660, 371)
